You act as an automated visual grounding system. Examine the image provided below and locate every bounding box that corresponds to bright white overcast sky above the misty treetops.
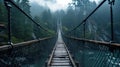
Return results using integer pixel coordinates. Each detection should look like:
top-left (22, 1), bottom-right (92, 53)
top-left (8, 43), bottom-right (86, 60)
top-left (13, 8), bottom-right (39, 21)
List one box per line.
top-left (30, 0), bottom-right (100, 11)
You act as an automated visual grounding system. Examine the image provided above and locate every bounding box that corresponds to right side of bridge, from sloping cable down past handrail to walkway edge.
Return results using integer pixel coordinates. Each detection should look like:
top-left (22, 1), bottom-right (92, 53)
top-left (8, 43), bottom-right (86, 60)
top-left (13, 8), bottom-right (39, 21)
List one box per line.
top-left (63, 0), bottom-right (120, 67)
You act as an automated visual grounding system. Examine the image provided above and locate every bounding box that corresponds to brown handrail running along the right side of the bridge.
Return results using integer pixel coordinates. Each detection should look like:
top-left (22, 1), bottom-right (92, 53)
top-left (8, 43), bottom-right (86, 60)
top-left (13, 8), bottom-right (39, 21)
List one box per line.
top-left (65, 36), bottom-right (120, 48)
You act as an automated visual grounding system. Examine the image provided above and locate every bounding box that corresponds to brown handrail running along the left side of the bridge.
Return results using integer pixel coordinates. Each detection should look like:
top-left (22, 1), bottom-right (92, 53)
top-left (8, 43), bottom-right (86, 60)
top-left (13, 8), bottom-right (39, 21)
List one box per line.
top-left (0, 36), bottom-right (54, 51)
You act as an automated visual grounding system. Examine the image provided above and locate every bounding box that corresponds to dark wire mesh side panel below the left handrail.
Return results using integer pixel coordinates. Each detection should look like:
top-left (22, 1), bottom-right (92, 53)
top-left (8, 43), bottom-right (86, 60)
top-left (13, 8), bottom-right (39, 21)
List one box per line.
top-left (0, 38), bottom-right (56, 67)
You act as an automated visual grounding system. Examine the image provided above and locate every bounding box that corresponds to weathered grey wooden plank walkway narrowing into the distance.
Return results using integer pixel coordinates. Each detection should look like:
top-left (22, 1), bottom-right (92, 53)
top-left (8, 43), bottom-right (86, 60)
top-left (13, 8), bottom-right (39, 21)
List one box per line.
top-left (47, 31), bottom-right (76, 67)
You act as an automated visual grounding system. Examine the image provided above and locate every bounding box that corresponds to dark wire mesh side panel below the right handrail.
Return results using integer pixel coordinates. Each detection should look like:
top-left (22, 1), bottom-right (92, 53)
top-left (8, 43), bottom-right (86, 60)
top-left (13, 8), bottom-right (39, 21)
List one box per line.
top-left (64, 37), bottom-right (120, 67)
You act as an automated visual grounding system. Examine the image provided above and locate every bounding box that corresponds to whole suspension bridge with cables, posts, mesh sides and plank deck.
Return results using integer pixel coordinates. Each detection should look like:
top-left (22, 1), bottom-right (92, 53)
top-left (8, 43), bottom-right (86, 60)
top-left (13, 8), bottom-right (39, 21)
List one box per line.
top-left (0, 0), bottom-right (120, 67)
